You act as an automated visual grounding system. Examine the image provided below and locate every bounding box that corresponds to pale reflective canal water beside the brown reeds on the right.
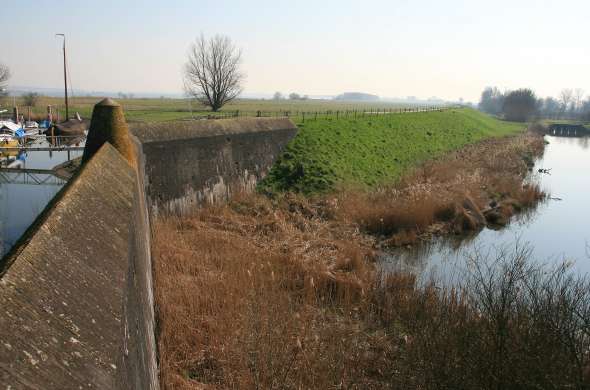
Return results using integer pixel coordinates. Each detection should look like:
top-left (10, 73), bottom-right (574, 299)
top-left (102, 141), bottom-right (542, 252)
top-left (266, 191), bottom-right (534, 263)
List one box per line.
top-left (380, 136), bottom-right (590, 281)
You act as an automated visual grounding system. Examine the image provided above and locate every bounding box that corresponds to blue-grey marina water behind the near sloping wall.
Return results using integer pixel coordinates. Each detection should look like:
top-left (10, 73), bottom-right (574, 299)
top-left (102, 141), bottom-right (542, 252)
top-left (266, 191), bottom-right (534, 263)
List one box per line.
top-left (0, 138), bottom-right (84, 257)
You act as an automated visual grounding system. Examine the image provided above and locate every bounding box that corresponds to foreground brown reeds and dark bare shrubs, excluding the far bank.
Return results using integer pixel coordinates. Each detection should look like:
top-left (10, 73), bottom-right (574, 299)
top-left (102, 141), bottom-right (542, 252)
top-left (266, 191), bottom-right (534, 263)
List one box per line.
top-left (154, 206), bottom-right (590, 389)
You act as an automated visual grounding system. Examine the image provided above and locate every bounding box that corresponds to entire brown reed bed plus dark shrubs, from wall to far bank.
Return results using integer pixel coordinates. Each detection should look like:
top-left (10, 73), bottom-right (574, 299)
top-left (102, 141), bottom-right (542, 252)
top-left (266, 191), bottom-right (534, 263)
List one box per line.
top-left (153, 133), bottom-right (590, 389)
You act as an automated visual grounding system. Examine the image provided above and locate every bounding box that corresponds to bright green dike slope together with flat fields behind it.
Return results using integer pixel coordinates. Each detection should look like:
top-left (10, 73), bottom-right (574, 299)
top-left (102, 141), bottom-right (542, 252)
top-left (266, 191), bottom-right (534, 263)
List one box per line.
top-left (3, 96), bottom-right (524, 194)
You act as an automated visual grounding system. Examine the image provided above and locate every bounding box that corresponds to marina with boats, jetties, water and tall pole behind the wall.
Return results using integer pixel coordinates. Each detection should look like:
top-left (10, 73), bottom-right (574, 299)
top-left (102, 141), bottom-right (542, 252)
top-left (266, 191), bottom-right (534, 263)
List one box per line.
top-left (0, 34), bottom-right (89, 258)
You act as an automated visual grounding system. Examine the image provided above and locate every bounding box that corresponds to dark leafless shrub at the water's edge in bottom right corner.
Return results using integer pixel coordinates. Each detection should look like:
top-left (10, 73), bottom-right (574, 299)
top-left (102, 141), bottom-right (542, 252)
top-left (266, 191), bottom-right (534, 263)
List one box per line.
top-left (401, 247), bottom-right (590, 389)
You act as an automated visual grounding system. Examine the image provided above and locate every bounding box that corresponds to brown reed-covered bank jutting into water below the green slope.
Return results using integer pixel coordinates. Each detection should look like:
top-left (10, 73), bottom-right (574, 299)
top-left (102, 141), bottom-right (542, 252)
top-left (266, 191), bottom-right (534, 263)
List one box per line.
top-left (333, 132), bottom-right (545, 246)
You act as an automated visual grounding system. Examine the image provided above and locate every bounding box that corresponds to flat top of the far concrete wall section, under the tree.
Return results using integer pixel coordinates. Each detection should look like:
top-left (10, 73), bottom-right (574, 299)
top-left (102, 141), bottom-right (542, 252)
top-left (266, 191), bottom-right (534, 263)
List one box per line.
top-left (131, 118), bottom-right (297, 143)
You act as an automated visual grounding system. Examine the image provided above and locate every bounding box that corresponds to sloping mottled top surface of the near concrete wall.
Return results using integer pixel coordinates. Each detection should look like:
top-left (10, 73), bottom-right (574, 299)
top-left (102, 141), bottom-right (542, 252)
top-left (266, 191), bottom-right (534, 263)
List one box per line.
top-left (0, 144), bottom-right (134, 389)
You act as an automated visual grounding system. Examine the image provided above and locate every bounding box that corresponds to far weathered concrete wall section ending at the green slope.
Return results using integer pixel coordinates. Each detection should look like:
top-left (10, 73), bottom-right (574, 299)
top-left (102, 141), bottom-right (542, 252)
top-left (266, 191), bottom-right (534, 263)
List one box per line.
top-left (132, 118), bottom-right (297, 213)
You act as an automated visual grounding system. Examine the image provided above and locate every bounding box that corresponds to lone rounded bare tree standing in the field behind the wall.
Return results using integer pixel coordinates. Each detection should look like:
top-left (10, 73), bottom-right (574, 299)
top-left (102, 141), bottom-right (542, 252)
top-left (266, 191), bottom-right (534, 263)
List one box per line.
top-left (184, 35), bottom-right (244, 111)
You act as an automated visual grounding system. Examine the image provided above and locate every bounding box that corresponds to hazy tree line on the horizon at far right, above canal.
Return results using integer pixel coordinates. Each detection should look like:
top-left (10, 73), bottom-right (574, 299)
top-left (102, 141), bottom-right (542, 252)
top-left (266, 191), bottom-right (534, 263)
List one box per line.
top-left (479, 87), bottom-right (590, 122)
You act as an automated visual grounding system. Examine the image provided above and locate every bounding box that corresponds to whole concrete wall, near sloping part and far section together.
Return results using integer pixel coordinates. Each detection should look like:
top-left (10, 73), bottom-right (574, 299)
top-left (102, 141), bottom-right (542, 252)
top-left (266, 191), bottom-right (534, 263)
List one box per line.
top-left (0, 119), bottom-right (296, 390)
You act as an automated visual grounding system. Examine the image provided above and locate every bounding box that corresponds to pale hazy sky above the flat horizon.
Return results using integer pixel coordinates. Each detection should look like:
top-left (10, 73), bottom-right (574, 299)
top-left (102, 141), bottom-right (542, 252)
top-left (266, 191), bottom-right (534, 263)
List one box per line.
top-left (0, 0), bottom-right (590, 101)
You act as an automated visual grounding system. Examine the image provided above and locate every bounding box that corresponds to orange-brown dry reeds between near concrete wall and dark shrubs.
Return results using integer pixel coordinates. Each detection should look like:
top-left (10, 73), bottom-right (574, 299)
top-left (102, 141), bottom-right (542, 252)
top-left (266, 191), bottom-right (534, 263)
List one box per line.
top-left (154, 196), bottom-right (388, 389)
